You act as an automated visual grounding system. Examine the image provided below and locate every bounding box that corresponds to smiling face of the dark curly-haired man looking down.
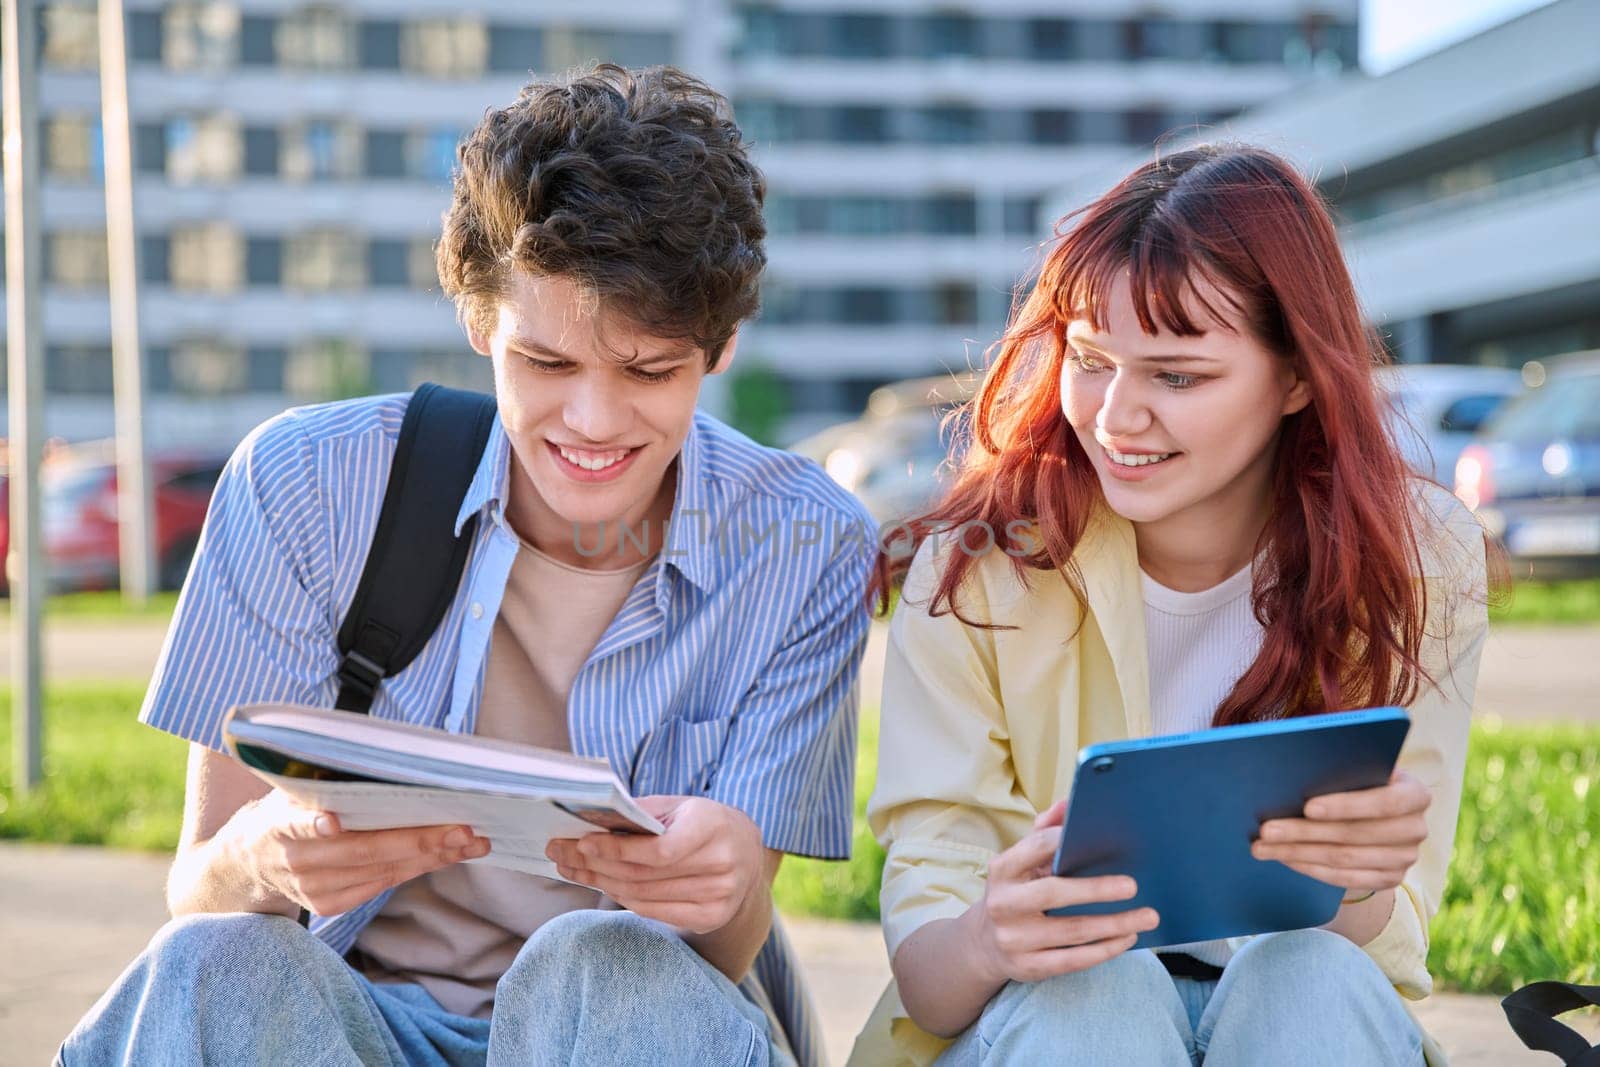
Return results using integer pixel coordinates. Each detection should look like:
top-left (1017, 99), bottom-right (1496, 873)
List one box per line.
top-left (469, 270), bottom-right (733, 552)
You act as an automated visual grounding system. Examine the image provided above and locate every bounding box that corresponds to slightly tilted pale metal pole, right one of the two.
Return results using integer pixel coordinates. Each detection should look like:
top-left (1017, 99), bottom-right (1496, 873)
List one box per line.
top-left (99, 0), bottom-right (155, 605)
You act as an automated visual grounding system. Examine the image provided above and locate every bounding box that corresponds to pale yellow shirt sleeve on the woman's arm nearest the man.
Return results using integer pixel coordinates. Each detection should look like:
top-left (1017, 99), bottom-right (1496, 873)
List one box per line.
top-left (867, 541), bottom-right (1035, 958)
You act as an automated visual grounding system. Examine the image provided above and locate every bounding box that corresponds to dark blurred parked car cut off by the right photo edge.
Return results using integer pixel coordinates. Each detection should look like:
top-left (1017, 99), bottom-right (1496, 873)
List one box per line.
top-left (1456, 350), bottom-right (1600, 577)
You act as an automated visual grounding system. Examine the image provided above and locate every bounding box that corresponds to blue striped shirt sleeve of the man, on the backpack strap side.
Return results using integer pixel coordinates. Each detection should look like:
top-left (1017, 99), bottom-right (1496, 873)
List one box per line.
top-left (139, 413), bottom-right (338, 750)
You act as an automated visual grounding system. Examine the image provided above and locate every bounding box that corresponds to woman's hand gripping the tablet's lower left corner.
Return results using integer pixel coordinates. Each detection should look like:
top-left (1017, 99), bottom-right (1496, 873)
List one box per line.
top-left (965, 800), bottom-right (1160, 984)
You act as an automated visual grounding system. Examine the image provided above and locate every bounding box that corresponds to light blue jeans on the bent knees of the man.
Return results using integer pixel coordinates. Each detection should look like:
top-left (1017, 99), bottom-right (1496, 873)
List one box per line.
top-left (59, 910), bottom-right (792, 1067)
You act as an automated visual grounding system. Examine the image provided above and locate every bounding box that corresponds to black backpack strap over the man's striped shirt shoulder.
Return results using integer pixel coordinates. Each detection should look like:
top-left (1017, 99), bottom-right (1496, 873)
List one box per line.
top-left (334, 384), bottom-right (494, 712)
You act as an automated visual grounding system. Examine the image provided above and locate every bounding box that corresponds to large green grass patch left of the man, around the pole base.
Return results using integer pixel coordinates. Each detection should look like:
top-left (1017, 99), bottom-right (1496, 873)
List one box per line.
top-left (0, 683), bottom-right (187, 849)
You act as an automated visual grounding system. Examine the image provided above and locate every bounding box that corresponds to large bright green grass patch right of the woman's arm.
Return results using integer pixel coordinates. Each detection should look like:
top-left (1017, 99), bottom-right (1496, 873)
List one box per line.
top-left (1429, 721), bottom-right (1600, 992)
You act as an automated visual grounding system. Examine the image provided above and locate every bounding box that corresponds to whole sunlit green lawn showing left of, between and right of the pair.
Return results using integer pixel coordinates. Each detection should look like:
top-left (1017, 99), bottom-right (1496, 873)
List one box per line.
top-left (0, 685), bottom-right (1600, 993)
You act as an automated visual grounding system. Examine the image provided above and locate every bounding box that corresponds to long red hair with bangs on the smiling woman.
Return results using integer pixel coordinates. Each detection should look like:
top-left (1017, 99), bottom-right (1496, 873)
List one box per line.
top-left (894, 146), bottom-right (1427, 725)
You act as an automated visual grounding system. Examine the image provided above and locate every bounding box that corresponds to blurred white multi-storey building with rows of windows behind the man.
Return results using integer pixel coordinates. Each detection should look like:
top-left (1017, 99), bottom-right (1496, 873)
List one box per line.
top-left (6, 0), bottom-right (1357, 443)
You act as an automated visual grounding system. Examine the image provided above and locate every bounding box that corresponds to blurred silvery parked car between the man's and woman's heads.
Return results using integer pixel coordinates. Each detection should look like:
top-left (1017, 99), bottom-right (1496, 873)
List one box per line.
top-left (790, 374), bottom-right (979, 523)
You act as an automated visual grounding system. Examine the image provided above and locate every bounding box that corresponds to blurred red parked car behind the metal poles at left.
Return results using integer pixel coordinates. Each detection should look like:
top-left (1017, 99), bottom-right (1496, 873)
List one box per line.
top-left (0, 442), bottom-right (227, 592)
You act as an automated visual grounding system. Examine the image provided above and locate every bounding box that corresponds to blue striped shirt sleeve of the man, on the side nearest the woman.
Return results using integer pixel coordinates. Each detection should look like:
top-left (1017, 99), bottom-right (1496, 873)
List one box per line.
top-left (709, 515), bottom-right (877, 859)
